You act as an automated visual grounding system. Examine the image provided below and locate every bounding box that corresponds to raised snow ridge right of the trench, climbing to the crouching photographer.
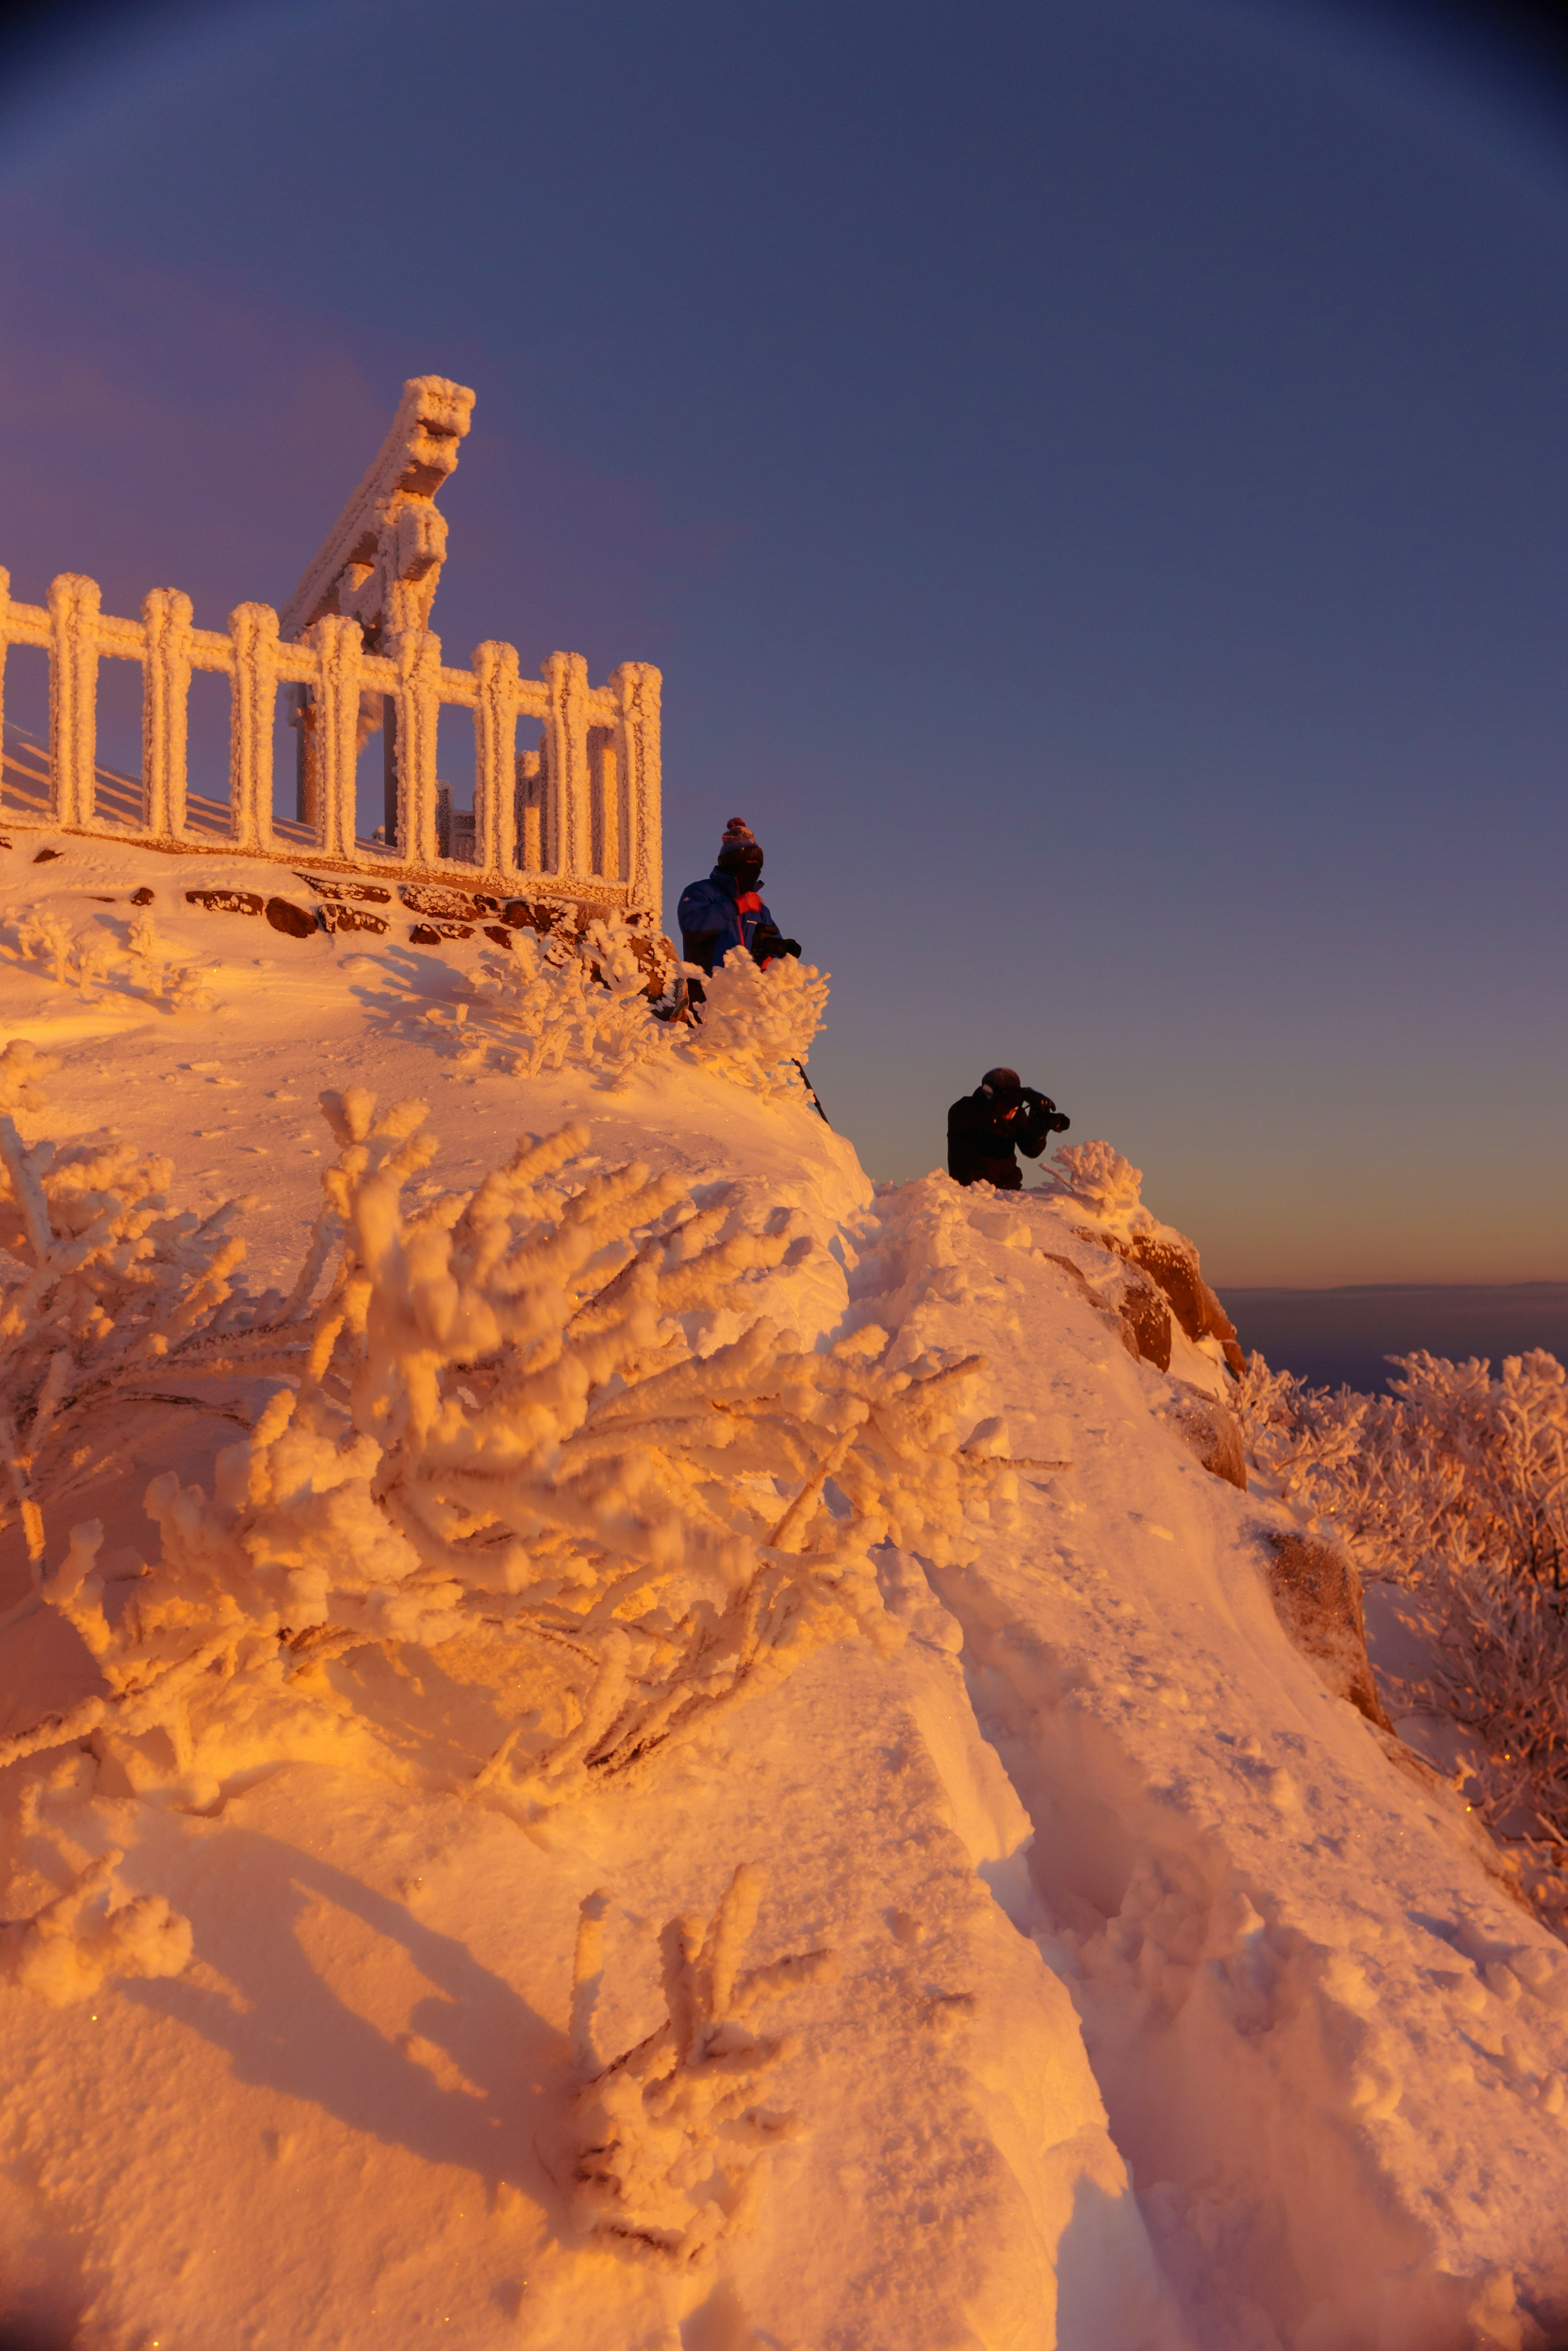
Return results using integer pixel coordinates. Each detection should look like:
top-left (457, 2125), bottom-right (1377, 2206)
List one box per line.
top-left (865, 1178), bottom-right (1568, 2351)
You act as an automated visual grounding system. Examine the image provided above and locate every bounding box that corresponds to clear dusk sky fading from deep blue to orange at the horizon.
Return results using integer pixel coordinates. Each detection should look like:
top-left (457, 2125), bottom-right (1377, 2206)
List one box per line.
top-left (0, 0), bottom-right (1568, 1284)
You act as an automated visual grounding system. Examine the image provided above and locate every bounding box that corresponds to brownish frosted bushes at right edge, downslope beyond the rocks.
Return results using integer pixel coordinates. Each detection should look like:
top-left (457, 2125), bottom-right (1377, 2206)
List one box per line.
top-left (1234, 1349), bottom-right (1568, 1890)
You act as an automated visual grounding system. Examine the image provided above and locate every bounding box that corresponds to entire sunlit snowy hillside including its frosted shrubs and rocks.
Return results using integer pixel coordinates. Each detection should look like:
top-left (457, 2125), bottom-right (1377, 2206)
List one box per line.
top-left (0, 834), bottom-right (1568, 2351)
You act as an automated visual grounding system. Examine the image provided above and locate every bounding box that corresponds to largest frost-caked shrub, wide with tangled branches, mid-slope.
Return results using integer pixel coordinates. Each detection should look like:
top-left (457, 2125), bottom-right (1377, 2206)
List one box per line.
top-left (0, 1089), bottom-right (1006, 1808)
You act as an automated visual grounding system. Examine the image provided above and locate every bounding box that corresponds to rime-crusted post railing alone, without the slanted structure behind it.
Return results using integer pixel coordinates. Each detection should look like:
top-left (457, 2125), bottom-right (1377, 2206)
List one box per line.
top-left (0, 571), bottom-right (663, 910)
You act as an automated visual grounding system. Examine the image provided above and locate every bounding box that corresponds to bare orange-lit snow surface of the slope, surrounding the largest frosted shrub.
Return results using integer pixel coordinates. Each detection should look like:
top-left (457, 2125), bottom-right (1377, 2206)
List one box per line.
top-left (0, 834), bottom-right (1568, 2351)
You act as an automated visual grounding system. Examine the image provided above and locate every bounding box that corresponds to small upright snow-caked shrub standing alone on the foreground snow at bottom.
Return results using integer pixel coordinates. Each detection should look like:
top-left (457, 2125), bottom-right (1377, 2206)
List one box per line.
top-left (571, 1862), bottom-right (837, 2266)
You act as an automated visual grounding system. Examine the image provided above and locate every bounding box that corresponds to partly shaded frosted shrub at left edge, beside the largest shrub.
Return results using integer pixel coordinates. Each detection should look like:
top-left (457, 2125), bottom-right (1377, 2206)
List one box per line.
top-left (0, 1039), bottom-right (320, 1577)
